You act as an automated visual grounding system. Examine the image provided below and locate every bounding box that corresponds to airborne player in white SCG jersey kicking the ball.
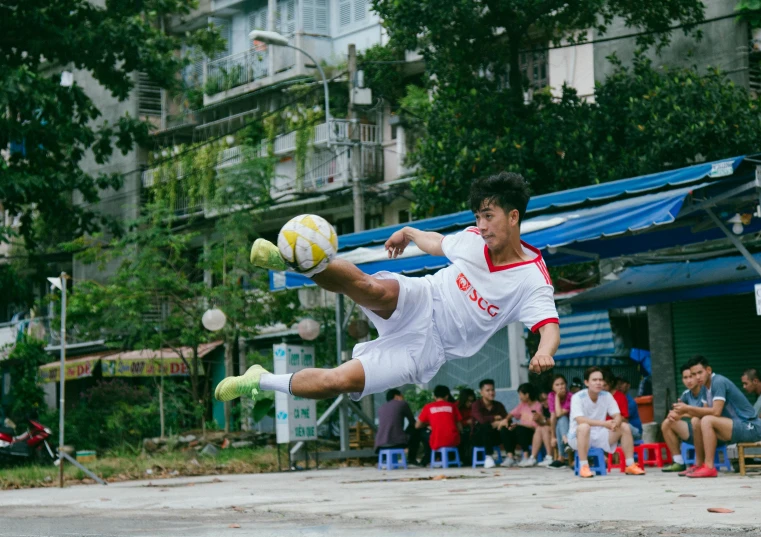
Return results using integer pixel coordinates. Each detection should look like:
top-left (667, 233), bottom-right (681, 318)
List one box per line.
top-left (214, 172), bottom-right (560, 401)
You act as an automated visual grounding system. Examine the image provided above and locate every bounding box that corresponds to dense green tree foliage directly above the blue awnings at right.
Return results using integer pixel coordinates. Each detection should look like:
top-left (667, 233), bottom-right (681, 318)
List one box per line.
top-left (400, 55), bottom-right (761, 216)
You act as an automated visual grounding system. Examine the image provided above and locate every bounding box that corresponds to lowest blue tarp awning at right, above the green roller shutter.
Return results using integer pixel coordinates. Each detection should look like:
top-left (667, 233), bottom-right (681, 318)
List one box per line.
top-left (565, 254), bottom-right (761, 312)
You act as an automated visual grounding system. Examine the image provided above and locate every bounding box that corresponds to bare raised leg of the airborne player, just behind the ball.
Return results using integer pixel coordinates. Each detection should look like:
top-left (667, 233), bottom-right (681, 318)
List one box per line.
top-left (312, 259), bottom-right (399, 319)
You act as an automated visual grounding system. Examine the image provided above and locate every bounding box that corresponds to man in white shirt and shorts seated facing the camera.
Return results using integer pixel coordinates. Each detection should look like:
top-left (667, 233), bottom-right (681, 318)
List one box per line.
top-left (568, 367), bottom-right (645, 478)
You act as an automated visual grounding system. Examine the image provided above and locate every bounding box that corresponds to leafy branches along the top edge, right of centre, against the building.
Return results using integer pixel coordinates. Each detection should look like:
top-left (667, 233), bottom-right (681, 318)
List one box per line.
top-left (373, 0), bottom-right (703, 103)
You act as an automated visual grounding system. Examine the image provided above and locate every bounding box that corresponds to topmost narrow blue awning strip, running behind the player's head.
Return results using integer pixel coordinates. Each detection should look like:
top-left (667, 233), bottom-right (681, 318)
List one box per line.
top-left (338, 153), bottom-right (745, 251)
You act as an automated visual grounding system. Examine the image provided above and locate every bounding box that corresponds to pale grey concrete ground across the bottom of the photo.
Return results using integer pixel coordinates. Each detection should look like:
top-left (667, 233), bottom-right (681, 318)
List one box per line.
top-left (0, 462), bottom-right (761, 537)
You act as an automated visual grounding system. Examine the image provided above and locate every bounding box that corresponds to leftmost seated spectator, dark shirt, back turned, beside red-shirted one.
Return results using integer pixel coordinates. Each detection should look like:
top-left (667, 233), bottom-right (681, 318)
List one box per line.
top-left (375, 389), bottom-right (420, 464)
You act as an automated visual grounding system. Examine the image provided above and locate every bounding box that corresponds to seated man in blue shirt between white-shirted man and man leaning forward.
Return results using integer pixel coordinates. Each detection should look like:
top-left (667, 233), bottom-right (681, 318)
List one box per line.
top-left (661, 360), bottom-right (706, 472)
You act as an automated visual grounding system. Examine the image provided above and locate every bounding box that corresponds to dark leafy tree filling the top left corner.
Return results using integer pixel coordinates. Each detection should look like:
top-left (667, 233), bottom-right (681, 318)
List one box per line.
top-left (0, 0), bottom-right (220, 250)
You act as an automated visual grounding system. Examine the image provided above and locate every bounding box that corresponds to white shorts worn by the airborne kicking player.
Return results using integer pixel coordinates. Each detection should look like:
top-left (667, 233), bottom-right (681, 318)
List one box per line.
top-left (350, 272), bottom-right (445, 401)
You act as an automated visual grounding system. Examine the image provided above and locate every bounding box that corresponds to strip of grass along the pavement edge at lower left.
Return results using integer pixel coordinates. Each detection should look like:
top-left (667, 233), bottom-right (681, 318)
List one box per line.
top-left (0, 448), bottom-right (277, 490)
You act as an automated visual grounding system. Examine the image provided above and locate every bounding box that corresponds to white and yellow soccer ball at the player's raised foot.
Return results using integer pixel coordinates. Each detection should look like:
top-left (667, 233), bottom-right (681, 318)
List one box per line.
top-left (277, 214), bottom-right (338, 273)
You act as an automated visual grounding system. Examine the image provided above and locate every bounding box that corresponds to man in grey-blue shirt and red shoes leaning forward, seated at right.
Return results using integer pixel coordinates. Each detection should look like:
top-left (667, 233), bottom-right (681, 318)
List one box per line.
top-left (674, 356), bottom-right (761, 478)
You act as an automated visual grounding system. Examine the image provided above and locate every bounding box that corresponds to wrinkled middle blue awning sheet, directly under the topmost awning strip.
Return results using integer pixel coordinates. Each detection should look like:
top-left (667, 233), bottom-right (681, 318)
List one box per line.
top-left (270, 185), bottom-right (703, 290)
